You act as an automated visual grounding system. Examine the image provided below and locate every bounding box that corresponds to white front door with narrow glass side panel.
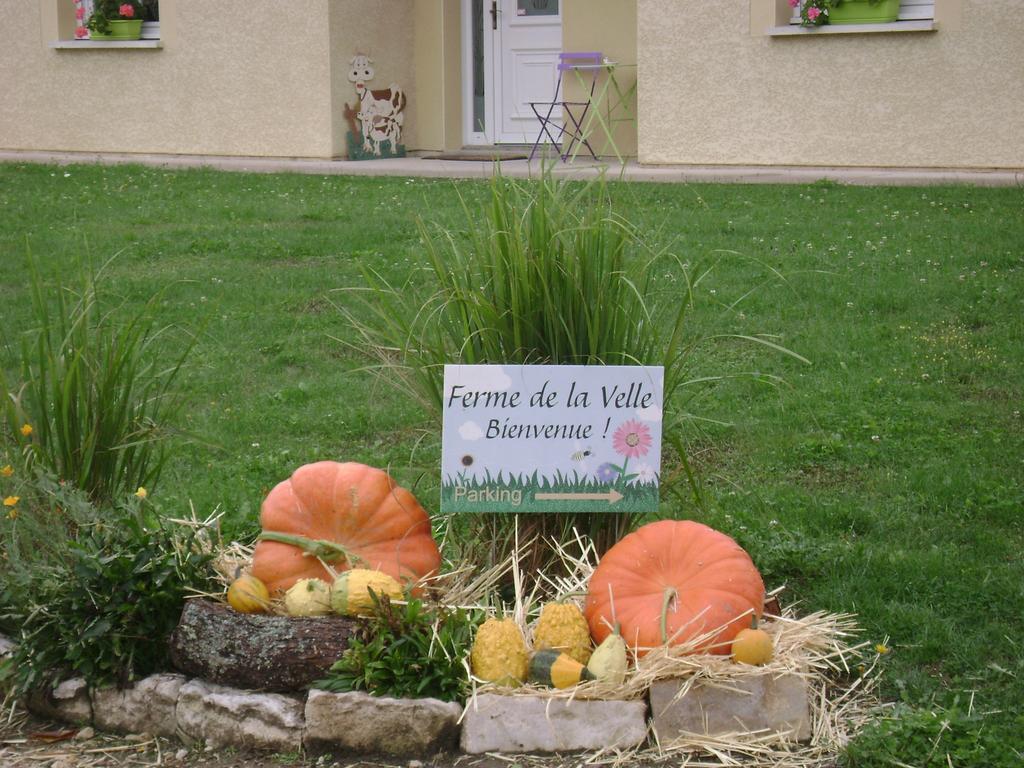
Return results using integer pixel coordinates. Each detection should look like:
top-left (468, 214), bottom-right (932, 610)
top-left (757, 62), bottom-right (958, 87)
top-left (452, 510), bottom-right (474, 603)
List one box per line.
top-left (463, 0), bottom-right (562, 144)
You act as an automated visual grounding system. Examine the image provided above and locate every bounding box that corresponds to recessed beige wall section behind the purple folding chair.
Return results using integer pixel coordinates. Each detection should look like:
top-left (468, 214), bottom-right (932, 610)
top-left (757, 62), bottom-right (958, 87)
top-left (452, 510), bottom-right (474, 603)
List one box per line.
top-left (562, 0), bottom-right (637, 157)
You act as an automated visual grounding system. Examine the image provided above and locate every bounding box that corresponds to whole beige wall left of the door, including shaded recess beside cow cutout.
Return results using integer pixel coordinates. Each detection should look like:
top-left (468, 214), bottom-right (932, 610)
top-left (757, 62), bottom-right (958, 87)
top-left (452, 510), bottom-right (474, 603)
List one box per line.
top-left (0, 0), bottom-right (444, 158)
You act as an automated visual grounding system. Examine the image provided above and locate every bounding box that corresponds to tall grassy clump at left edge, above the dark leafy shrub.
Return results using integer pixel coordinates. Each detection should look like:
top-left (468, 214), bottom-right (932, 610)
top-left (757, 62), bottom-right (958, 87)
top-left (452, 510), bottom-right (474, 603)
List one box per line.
top-left (0, 261), bottom-right (193, 502)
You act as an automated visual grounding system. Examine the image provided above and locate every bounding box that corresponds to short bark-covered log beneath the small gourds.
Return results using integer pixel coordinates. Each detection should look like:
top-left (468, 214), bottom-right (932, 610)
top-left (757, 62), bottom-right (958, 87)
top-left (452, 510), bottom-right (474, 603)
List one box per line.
top-left (170, 600), bottom-right (361, 691)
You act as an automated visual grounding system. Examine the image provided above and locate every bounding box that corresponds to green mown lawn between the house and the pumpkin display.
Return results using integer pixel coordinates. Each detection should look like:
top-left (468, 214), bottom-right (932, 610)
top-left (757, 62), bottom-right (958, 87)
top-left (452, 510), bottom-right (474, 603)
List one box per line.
top-left (0, 165), bottom-right (1024, 765)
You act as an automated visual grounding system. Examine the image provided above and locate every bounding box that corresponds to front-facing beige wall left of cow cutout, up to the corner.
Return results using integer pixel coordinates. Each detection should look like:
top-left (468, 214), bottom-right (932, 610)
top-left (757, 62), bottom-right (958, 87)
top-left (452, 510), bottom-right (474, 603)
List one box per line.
top-left (0, 0), bottom-right (337, 157)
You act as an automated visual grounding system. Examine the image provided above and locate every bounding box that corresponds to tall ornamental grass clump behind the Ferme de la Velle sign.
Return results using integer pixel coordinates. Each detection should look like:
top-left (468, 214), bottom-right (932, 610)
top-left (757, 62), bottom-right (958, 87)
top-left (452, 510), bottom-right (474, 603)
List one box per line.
top-left (337, 171), bottom-right (695, 562)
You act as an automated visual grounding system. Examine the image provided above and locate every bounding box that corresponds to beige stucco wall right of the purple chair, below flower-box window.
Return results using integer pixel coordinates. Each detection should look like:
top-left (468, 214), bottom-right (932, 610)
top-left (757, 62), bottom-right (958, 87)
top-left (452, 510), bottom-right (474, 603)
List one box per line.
top-left (637, 0), bottom-right (1024, 168)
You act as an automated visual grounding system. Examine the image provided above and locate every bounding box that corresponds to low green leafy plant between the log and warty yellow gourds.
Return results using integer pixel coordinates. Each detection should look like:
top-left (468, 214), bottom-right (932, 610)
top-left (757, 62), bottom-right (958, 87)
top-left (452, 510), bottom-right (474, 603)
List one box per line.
top-left (313, 595), bottom-right (483, 701)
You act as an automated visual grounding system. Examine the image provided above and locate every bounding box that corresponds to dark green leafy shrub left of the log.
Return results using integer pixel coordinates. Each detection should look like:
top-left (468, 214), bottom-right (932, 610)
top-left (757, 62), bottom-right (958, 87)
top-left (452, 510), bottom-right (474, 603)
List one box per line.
top-left (0, 479), bottom-right (210, 691)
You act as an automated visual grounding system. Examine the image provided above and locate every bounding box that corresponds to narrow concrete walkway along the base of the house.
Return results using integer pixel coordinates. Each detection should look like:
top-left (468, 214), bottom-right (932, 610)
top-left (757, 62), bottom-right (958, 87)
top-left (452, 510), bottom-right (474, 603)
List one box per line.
top-left (0, 150), bottom-right (1024, 186)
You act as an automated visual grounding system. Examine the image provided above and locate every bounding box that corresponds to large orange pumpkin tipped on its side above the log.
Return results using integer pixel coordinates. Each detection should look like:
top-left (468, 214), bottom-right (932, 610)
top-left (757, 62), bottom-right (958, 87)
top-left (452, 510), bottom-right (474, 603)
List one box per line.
top-left (252, 462), bottom-right (441, 594)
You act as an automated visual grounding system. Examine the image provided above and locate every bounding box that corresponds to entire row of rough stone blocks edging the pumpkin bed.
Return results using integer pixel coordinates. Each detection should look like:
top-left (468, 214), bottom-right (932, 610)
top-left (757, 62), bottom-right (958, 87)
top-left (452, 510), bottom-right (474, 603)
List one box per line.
top-left (0, 636), bottom-right (810, 758)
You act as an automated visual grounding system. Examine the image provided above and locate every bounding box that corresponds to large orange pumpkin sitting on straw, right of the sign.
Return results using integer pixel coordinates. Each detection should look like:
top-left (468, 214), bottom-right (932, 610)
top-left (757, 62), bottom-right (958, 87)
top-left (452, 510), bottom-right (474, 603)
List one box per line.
top-left (584, 520), bottom-right (765, 655)
